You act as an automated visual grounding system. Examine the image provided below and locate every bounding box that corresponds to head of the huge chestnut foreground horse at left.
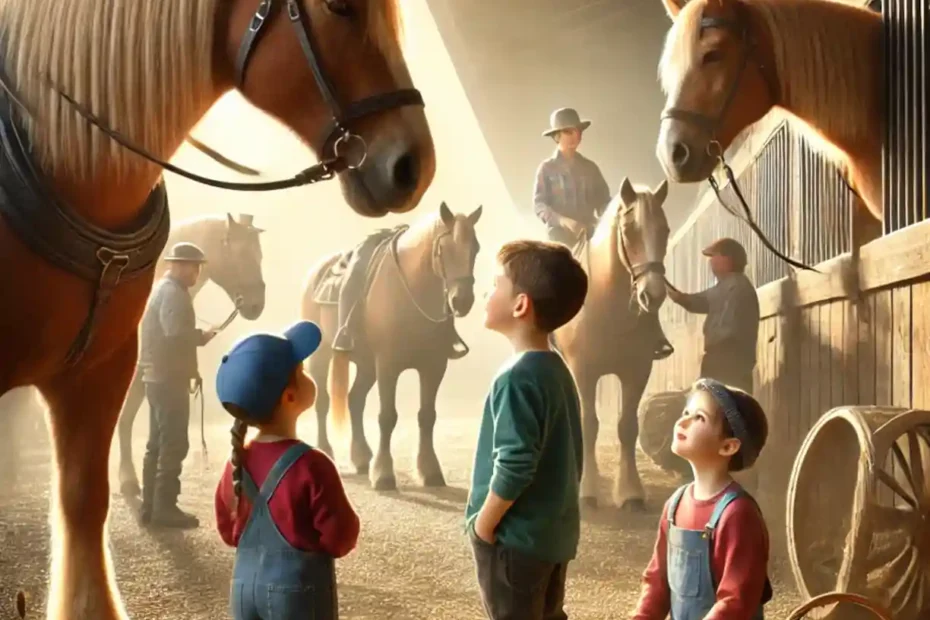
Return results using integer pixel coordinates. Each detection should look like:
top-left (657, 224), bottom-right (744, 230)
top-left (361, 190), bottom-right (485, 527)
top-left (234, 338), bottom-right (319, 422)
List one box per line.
top-left (228, 0), bottom-right (436, 217)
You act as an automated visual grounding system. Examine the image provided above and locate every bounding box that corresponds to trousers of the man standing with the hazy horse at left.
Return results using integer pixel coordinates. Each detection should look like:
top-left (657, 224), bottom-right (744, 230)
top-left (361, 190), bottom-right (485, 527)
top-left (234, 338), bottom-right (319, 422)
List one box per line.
top-left (142, 380), bottom-right (191, 512)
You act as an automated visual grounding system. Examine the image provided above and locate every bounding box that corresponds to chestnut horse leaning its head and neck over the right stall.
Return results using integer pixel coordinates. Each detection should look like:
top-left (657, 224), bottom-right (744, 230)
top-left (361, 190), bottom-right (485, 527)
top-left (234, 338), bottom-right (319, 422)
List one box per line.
top-left (656, 0), bottom-right (886, 222)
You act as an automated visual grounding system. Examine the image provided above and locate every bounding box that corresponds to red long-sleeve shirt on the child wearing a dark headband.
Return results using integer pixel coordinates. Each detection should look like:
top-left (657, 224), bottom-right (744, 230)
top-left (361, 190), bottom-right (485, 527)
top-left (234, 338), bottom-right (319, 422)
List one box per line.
top-left (632, 487), bottom-right (769, 620)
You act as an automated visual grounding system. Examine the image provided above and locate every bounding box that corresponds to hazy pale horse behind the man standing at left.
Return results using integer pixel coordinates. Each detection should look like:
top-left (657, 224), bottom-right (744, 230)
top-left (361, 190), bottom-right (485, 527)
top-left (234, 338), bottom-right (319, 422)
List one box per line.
top-left (118, 214), bottom-right (265, 496)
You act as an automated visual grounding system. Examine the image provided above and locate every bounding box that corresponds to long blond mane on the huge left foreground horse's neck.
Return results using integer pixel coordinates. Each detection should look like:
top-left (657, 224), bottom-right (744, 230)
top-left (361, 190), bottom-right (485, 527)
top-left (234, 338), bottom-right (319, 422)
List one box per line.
top-left (0, 0), bottom-right (218, 175)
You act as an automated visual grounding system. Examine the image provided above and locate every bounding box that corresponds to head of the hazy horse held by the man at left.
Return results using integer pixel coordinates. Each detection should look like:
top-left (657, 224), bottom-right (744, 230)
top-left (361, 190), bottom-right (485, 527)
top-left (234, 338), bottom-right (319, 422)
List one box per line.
top-left (208, 213), bottom-right (265, 321)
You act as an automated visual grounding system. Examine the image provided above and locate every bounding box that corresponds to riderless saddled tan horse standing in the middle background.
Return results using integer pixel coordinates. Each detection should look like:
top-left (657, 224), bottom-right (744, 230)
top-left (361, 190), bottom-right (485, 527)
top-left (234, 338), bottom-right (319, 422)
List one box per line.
top-left (301, 203), bottom-right (481, 490)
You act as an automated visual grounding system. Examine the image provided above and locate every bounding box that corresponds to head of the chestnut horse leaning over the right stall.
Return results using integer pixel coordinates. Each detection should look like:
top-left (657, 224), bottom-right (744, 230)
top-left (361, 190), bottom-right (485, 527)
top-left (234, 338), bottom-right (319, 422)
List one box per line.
top-left (656, 0), bottom-right (778, 183)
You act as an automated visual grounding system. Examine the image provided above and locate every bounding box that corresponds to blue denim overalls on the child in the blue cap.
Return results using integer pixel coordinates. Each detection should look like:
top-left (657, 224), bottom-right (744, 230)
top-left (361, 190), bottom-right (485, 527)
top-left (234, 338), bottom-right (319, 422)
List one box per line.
top-left (230, 443), bottom-right (339, 620)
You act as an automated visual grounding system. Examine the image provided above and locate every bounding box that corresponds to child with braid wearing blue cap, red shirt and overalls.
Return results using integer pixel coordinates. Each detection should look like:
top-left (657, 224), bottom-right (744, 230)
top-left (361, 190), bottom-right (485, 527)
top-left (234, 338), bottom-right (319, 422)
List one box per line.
top-left (216, 321), bottom-right (359, 620)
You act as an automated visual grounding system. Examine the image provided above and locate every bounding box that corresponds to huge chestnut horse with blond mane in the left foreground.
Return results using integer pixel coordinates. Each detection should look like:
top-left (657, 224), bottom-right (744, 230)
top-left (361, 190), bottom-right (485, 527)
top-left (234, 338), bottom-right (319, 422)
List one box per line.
top-left (0, 0), bottom-right (435, 620)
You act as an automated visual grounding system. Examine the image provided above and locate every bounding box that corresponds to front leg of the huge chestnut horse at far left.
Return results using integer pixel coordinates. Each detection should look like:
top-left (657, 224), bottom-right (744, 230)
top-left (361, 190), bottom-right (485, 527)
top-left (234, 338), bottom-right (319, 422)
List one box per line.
top-left (40, 334), bottom-right (136, 620)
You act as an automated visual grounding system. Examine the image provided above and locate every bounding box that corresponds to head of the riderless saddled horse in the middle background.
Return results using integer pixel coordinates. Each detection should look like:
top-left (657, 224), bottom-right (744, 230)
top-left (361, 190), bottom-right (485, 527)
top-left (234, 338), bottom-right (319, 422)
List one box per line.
top-left (433, 202), bottom-right (481, 317)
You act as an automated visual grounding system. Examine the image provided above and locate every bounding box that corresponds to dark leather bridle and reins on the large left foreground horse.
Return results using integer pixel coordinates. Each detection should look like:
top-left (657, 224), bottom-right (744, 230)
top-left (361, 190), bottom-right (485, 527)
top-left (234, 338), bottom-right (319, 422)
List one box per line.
top-left (0, 0), bottom-right (425, 192)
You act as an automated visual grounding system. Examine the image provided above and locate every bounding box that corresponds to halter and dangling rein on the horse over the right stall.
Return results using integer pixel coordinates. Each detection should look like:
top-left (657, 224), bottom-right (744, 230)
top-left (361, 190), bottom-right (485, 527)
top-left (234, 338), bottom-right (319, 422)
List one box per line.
top-left (659, 17), bottom-right (817, 272)
